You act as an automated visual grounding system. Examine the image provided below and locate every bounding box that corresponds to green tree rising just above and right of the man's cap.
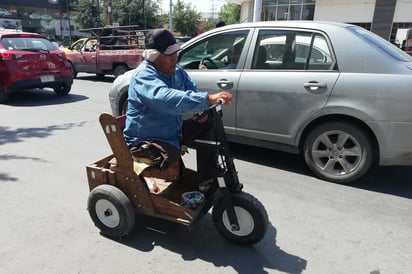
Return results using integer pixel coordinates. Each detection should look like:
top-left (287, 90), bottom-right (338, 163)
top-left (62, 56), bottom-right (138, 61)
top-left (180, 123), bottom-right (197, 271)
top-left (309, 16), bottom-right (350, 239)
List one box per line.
top-left (172, 0), bottom-right (200, 36)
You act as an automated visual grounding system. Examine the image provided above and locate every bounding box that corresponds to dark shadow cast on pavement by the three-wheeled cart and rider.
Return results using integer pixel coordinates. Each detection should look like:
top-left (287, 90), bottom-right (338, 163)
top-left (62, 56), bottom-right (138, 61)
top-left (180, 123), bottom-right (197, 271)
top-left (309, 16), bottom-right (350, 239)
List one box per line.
top-left (112, 214), bottom-right (307, 274)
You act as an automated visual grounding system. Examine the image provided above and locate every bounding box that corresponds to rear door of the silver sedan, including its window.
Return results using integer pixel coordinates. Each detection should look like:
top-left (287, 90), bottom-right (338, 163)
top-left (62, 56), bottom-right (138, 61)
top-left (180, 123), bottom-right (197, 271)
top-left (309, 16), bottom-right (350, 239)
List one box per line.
top-left (236, 29), bottom-right (339, 145)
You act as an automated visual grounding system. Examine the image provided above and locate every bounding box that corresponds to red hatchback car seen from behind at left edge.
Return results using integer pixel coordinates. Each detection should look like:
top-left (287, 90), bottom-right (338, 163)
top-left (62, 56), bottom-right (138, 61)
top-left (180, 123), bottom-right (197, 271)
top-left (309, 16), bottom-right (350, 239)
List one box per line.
top-left (0, 30), bottom-right (73, 103)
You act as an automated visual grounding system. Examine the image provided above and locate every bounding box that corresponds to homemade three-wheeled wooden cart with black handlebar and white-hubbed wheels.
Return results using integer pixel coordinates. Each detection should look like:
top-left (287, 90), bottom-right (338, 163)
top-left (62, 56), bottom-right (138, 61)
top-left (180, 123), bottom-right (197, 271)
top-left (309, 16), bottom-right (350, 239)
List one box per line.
top-left (86, 102), bottom-right (269, 245)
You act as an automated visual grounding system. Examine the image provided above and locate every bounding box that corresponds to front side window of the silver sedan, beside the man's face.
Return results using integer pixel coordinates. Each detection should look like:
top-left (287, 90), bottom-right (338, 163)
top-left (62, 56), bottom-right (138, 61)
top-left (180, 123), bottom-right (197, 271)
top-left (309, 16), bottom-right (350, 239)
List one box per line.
top-left (179, 30), bottom-right (249, 69)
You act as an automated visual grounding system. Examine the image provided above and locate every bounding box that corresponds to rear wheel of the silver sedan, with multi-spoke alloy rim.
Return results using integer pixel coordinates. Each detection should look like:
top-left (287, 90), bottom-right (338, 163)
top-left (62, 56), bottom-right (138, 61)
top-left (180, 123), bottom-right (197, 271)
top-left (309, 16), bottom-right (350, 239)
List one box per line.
top-left (303, 122), bottom-right (374, 183)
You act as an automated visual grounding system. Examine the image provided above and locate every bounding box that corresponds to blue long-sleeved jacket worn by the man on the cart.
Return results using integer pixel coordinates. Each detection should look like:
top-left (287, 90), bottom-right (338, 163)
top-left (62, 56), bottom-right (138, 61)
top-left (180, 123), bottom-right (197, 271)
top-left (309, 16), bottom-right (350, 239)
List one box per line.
top-left (123, 60), bottom-right (210, 148)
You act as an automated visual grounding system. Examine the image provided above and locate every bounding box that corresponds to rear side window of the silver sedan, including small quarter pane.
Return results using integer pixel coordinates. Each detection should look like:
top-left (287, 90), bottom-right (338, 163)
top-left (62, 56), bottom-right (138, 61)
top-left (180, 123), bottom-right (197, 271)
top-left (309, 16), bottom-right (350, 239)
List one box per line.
top-left (252, 30), bottom-right (334, 70)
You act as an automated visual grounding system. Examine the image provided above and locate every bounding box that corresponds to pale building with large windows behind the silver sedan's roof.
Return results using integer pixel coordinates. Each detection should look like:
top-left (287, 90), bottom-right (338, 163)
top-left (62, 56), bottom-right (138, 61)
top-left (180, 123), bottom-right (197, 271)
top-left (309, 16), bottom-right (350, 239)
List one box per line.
top-left (227, 0), bottom-right (412, 44)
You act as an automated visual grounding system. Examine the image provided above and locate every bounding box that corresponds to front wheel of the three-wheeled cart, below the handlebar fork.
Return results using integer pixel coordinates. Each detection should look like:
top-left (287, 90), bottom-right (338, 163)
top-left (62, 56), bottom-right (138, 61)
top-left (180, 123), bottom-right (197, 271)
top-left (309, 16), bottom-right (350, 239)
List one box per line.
top-left (212, 192), bottom-right (269, 245)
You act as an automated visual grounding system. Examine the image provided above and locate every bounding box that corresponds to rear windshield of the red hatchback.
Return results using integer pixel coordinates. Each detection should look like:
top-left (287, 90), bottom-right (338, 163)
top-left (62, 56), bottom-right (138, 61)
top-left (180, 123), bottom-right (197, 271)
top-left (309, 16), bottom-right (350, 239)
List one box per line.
top-left (1, 36), bottom-right (57, 51)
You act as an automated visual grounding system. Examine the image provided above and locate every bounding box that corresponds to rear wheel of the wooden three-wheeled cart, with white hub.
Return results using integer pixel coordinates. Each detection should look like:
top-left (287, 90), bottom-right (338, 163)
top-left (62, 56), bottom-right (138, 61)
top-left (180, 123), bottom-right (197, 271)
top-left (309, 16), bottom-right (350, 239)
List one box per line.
top-left (87, 184), bottom-right (135, 238)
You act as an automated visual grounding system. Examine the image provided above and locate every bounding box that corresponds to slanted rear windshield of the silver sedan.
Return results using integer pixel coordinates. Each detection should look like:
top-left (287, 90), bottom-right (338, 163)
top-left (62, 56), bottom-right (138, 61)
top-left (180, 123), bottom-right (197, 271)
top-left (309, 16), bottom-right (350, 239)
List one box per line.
top-left (348, 26), bottom-right (412, 62)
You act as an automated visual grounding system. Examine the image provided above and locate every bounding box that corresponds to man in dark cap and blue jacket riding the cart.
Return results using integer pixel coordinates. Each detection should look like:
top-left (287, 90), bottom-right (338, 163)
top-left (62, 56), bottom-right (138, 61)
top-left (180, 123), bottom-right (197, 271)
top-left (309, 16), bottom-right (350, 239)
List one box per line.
top-left (124, 29), bottom-right (232, 184)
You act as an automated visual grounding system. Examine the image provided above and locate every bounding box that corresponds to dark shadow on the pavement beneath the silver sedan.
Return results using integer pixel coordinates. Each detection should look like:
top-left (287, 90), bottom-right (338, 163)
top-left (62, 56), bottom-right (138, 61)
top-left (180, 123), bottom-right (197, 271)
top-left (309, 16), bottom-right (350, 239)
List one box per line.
top-left (230, 143), bottom-right (412, 199)
